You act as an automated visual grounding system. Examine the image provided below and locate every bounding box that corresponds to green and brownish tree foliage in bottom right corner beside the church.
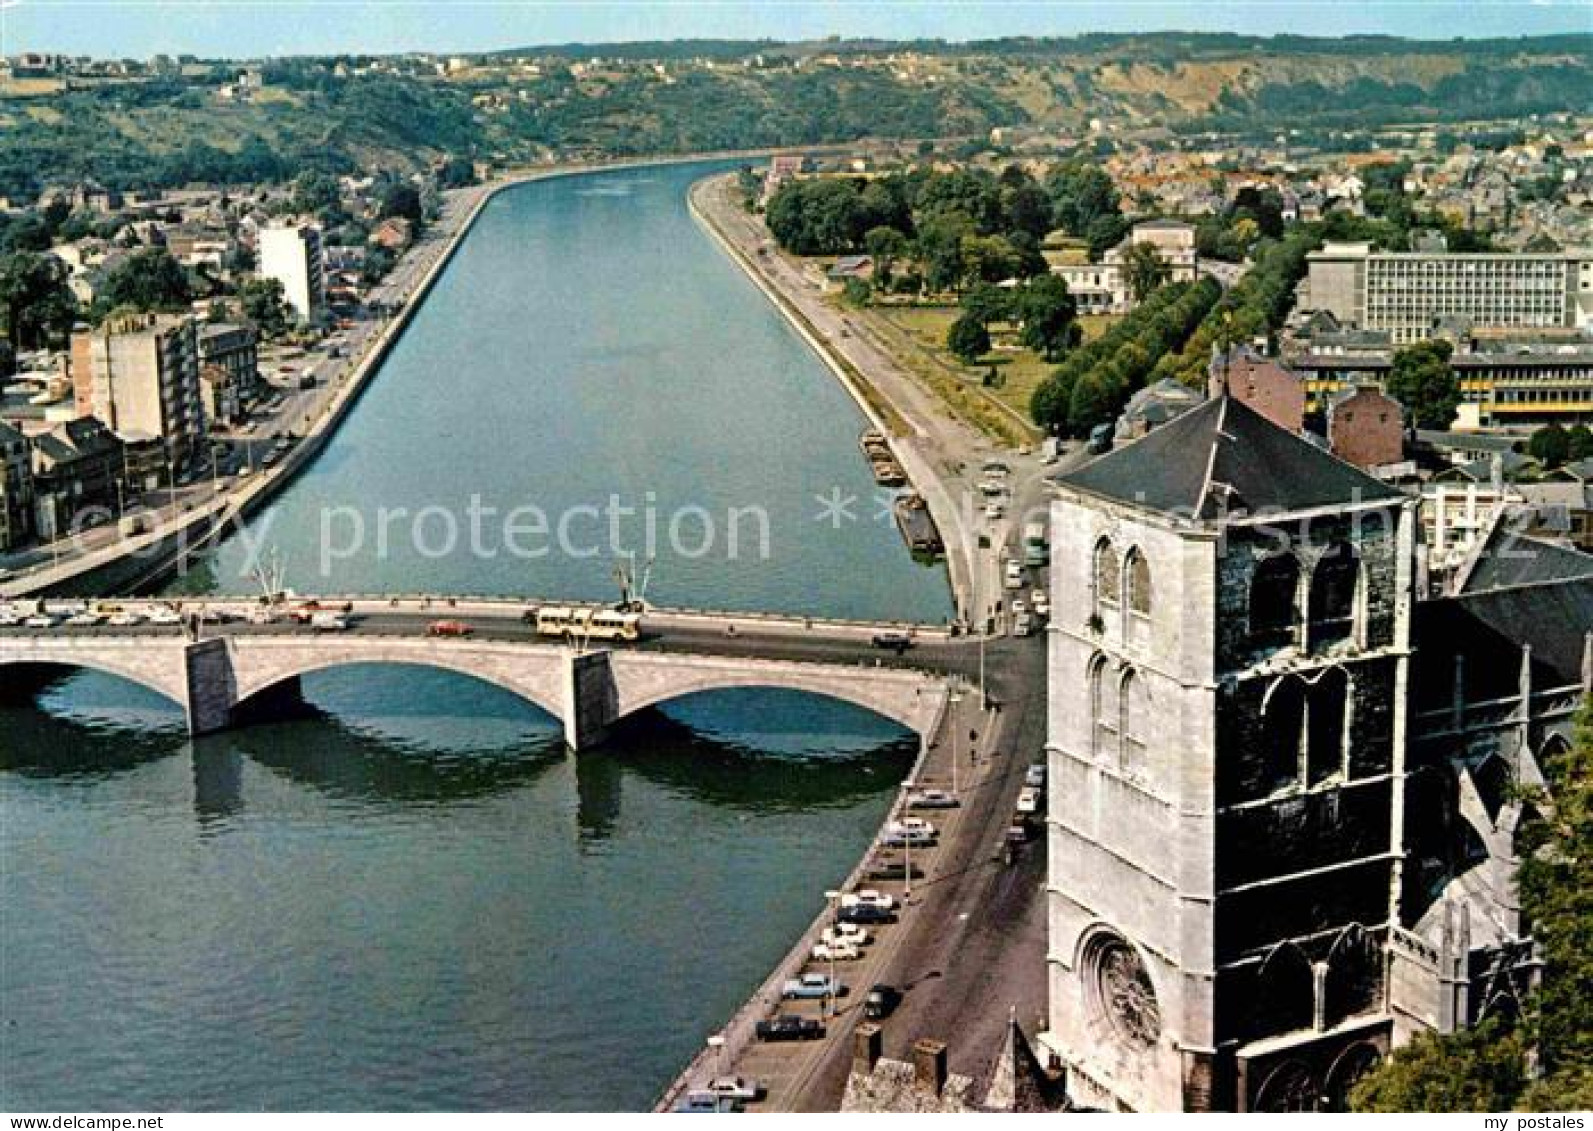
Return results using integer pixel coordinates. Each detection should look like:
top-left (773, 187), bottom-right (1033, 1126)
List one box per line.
top-left (1351, 699), bottom-right (1593, 1112)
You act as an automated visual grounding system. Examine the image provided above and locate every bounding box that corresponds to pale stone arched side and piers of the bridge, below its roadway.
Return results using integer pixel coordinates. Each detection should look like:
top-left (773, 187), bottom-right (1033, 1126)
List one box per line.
top-left (0, 628), bottom-right (951, 750)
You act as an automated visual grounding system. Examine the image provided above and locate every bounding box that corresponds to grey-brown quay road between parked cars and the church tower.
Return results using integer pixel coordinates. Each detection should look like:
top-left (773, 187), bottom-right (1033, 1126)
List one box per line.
top-left (655, 627), bottom-right (1047, 1112)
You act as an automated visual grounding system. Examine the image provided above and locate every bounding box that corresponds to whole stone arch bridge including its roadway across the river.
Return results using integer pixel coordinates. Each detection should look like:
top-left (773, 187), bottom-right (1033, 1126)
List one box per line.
top-left (0, 597), bottom-right (994, 750)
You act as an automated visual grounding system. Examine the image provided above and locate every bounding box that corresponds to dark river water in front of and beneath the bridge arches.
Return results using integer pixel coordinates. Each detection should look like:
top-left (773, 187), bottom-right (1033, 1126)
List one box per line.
top-left (0, 667), bottom-right (914, 1110)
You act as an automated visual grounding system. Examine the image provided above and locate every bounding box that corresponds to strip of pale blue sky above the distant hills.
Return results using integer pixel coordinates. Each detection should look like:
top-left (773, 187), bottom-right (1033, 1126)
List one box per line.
top-left (0, 0), bottom-right (1593, 57)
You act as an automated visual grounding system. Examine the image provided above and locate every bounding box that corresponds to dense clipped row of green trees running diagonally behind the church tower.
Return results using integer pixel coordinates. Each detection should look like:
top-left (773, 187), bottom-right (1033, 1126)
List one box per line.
top-left (1029, 279), bottom-right (1222, 435)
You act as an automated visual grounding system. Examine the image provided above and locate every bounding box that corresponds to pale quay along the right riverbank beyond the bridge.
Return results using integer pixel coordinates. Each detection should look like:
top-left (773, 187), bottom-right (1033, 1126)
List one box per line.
top-left (690, 177), bottom-right (1043, 637)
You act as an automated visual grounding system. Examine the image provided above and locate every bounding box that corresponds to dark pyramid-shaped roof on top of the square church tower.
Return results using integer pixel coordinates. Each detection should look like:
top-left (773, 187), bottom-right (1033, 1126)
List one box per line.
top-left (1058, 397), bottom-right (1405, 519)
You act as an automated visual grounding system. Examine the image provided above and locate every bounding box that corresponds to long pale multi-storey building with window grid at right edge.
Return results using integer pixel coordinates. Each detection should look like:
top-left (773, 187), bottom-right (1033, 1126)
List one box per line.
top-left (1306, 242), bottom-right (1593, 342)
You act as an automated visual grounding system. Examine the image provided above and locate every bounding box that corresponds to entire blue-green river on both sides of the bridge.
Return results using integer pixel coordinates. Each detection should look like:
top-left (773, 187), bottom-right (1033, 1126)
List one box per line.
top-left (0, 166), bottom-right (949, 1110)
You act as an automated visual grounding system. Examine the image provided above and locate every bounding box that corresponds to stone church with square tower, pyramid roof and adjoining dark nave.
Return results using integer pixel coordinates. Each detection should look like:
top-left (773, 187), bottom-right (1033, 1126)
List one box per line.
top-left (1042, 395), bottom-right (1593, 1112)
